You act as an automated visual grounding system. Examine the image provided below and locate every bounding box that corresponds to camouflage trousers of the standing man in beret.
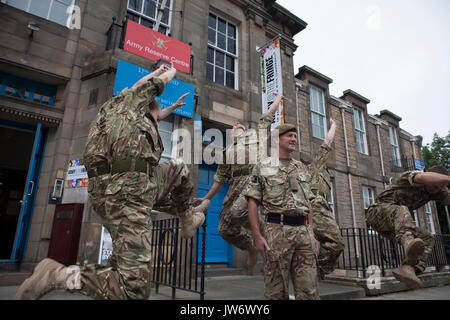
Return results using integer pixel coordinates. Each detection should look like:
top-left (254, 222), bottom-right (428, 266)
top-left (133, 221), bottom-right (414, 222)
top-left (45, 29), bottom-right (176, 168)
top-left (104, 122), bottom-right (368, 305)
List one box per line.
top-left (264, 222), bottom-right (320, 300)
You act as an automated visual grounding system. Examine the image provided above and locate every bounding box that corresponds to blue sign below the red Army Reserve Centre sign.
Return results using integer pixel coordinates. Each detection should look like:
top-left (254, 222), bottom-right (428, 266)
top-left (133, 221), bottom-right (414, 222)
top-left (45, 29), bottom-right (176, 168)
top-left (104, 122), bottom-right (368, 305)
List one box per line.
top-left (114, 60), bottom-right (195, 118)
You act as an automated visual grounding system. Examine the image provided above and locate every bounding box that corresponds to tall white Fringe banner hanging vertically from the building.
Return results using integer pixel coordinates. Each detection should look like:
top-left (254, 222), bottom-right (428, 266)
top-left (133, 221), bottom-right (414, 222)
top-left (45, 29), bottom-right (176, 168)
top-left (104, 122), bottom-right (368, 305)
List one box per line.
top-left (259, 38), bottom-right (284, 130)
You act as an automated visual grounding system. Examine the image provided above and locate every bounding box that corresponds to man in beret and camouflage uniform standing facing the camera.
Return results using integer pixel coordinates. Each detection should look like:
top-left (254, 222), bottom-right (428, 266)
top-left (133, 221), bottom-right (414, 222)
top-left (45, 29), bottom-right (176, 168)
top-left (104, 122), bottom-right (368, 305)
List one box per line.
top-left (244, 124), bottom-right (319, 300)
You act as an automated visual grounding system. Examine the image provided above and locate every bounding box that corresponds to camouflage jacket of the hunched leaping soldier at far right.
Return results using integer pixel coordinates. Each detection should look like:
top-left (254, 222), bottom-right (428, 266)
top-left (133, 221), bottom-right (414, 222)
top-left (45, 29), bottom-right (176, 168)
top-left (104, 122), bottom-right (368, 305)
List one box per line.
top-left (375, 171), bottom-right (450, 210)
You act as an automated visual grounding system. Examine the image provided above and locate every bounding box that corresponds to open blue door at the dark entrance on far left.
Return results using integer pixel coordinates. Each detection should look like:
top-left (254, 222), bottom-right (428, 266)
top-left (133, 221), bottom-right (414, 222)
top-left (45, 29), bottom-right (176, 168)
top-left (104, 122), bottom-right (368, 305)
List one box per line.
top-left (0, 119), bottom-right (47, 263)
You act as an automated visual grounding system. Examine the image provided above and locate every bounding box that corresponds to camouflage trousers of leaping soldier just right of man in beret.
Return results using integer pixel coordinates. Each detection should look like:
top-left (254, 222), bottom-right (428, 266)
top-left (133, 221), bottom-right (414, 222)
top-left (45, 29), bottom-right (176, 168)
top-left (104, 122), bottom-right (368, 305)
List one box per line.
top-left (311, 195), bottom-right (344, 274)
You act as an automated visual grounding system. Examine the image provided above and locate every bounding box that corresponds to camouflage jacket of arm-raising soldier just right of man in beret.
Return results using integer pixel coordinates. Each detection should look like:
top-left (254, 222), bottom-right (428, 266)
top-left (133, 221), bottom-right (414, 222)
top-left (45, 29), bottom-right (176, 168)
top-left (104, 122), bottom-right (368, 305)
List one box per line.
top-left (308, 143), bottom-right (331, 199)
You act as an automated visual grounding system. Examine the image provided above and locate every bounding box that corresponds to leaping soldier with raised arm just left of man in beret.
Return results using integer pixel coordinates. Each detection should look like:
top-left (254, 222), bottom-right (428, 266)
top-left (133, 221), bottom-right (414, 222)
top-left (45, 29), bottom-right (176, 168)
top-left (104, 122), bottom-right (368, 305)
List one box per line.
top-left (194, 93), bottom-right (284, 273)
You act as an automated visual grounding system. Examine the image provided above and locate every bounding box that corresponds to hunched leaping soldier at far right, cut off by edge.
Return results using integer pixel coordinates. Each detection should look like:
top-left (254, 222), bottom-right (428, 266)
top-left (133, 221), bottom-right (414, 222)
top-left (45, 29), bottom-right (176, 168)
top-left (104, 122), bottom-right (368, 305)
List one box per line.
top-left (366, 166), bottom-right (450, 289)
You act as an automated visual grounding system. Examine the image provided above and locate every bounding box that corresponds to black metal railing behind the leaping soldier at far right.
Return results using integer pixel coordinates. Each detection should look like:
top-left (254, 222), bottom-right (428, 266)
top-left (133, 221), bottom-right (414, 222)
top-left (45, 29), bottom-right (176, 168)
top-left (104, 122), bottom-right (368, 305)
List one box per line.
top-left (337, 228), bottom-right (450, 278)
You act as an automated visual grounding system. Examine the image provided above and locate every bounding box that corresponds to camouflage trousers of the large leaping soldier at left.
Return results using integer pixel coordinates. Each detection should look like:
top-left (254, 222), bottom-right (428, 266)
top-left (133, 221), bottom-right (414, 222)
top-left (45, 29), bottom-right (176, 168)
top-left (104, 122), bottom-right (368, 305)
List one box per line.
top-left (80, 160), bottom-right (194, 299)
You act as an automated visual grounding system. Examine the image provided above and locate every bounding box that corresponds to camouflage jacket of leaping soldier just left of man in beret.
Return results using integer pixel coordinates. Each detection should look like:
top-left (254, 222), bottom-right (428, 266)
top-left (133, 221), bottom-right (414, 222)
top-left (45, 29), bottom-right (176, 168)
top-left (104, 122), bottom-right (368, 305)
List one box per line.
top-left (214, 114), bottom-right (274, 207)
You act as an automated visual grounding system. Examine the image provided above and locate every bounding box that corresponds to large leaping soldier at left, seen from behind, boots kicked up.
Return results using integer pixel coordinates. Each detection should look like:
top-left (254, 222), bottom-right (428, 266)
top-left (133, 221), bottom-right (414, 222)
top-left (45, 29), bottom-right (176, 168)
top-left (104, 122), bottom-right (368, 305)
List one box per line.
top-left (16, 66), bottom-right (209, 299)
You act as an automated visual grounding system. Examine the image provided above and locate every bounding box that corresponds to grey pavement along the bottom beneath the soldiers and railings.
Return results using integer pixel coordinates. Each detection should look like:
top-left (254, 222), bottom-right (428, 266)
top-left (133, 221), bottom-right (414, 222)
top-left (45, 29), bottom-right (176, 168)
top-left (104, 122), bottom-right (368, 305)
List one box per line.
top-left (0, 275), bottom-right (450, 300)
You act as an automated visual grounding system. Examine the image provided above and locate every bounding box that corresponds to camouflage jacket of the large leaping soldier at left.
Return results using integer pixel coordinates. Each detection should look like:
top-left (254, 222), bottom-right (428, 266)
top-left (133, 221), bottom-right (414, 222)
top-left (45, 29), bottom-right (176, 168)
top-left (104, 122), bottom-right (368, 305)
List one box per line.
top-left (84, 78), bottom-right (164, 170)
